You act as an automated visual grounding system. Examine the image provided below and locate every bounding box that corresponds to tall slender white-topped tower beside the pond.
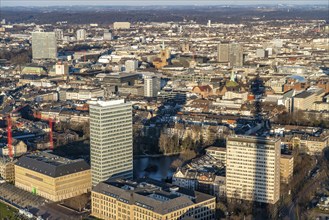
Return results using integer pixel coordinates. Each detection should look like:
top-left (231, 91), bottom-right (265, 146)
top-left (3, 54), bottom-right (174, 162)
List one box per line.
top-left (89, 99), bottom-right (133, 186)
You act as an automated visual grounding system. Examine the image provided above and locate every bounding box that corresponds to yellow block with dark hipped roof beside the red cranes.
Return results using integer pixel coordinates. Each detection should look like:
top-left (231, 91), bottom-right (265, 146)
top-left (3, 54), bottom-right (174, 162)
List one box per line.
top-left (15, 152), bottom-right (91, 202)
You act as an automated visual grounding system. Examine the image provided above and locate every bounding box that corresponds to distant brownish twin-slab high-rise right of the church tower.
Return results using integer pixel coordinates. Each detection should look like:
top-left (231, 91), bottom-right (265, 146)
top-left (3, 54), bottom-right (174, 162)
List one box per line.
top-left (217, 42), bottom-right (243, 66)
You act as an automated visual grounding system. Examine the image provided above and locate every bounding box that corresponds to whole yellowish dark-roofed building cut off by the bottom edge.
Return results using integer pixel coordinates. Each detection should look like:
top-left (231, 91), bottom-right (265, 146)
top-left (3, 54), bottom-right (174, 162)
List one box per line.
top-left (91, 179), bottom-right (216, 220)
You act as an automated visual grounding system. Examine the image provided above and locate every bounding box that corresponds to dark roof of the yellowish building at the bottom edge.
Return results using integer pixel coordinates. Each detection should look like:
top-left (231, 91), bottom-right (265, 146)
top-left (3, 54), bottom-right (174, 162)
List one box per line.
top-left (93, 178), bottom-right (215, 215)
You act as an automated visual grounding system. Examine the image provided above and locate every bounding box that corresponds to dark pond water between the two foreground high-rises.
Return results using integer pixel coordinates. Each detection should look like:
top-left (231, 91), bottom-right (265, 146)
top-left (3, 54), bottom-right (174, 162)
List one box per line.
top-left (134, 156), bottom-right (178, 180)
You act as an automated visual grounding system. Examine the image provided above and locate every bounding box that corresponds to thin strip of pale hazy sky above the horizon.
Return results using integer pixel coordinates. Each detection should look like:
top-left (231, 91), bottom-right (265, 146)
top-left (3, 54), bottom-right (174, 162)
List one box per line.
top-left (0, 0), bottom-right (329, 7)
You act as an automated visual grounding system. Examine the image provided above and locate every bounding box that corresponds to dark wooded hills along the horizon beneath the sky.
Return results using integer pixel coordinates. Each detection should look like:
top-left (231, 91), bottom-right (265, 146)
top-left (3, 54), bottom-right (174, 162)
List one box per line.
top-left (0, 6), bottom-right (328, 25)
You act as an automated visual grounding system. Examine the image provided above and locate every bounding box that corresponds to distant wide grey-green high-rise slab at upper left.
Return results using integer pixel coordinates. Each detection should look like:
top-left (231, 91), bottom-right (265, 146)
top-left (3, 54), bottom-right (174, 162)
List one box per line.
top-left (32, 31), bottom-right (57, 59)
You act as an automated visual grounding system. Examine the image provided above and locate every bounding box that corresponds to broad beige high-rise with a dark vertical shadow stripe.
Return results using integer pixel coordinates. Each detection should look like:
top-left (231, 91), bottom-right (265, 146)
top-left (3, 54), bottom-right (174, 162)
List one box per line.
top-left (226, 136), bottom-right (281, 204)
